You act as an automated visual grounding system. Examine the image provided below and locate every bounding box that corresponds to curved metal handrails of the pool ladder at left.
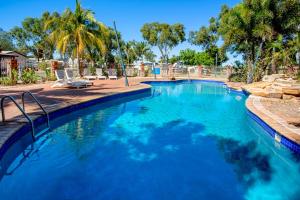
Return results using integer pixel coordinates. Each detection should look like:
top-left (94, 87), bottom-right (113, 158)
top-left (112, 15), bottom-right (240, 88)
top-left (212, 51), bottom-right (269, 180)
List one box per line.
top-left (0, 91), bottom-right (50, 140)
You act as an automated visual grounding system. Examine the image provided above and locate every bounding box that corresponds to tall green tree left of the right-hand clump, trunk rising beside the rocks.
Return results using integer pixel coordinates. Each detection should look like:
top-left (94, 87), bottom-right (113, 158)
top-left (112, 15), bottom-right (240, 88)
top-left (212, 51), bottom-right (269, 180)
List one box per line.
top-left (218, 0), bottom-right (272, 83)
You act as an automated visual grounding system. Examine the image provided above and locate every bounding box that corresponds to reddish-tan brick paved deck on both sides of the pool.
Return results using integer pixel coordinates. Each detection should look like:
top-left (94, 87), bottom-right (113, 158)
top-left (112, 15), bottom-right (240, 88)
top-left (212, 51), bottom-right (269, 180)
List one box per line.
top-left (0, 78), bottom-right (300, 152)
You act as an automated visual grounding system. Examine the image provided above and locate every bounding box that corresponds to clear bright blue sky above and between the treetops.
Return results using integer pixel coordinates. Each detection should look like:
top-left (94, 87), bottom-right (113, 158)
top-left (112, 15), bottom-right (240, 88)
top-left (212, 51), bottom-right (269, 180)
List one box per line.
top-left (0, 0), bottom-right (240, 62)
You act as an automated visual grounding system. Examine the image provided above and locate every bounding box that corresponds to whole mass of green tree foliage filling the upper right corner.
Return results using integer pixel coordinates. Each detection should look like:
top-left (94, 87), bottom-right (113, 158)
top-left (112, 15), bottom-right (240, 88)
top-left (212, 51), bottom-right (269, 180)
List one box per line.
top-left (218, 0), bottom-right (300, 82)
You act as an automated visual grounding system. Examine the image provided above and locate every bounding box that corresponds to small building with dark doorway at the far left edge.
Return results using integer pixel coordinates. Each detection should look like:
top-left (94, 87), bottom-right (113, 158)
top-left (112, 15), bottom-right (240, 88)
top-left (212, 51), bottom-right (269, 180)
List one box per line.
top-left (0, 50), bottom-right (27, 77)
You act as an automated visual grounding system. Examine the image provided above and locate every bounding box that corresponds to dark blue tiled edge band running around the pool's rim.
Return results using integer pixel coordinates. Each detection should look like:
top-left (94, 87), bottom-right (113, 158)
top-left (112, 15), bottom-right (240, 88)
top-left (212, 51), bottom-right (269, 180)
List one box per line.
top-left (0, 79), bottom-right (300, 160)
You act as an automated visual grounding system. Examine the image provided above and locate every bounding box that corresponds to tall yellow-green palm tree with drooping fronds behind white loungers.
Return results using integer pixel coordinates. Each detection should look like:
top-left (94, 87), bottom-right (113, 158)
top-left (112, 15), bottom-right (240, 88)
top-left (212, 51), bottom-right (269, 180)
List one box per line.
top-left (46, 0), bottom-right (108, 75)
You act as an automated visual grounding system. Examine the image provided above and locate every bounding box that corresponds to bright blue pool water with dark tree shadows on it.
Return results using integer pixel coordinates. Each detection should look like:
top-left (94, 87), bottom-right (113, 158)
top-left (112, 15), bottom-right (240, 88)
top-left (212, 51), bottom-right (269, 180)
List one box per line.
top-left (0, 82), bottom-right (300, 200)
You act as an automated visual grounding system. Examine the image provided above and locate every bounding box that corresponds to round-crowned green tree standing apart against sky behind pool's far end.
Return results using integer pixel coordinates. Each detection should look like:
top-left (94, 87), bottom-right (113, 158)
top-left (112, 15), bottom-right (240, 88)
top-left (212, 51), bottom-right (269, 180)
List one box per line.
top-left (141, 22), bottom-right (185, 62)
